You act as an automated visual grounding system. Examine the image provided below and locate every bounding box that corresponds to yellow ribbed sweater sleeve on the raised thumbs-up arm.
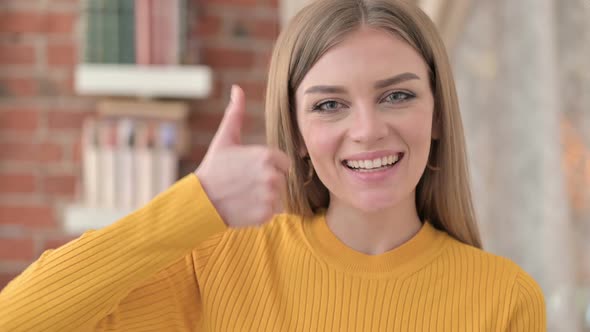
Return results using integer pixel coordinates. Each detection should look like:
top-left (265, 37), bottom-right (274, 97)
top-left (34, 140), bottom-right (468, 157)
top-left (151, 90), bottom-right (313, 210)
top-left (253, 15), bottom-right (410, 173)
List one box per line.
top-left (0, 174), bottom-right (227, 331)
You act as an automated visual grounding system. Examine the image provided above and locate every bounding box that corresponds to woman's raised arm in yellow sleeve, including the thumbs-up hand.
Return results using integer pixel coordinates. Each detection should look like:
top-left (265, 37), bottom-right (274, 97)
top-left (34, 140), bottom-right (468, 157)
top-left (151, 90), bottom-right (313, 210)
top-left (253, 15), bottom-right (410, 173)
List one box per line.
top-left (0, 86), bottom-right (290, 331)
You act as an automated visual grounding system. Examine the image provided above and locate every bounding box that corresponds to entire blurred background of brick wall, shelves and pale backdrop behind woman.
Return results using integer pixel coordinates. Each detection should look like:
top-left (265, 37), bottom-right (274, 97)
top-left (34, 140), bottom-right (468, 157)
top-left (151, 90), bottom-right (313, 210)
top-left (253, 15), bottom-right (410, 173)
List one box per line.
top-left (0, 0), bottom-right (590, 331)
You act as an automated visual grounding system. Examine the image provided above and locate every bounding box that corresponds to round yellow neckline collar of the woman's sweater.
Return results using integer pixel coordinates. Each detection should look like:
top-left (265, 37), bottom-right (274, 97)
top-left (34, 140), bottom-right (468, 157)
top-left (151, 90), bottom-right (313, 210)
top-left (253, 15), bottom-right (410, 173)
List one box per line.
top-left (303, 212), bottom-right (448, 275)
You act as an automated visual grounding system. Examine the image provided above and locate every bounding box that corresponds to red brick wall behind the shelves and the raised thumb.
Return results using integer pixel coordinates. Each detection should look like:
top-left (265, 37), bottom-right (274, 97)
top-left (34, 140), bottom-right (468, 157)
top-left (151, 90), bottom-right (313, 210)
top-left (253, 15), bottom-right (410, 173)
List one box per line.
top-left (0, 0), bottom-right (278, 289)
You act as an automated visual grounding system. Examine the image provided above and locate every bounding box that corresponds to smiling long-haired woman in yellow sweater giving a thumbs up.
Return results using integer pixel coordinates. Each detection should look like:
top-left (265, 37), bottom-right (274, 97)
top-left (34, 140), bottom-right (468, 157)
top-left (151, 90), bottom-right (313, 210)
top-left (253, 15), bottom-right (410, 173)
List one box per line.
top-left (0, 0), bottom-right (545, 331)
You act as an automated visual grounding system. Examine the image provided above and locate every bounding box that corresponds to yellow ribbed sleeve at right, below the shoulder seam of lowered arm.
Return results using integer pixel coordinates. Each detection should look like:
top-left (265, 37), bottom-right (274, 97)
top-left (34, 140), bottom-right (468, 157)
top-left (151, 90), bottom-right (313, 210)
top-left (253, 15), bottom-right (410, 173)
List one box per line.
top-left (507, 270), bottom-right (547, 332)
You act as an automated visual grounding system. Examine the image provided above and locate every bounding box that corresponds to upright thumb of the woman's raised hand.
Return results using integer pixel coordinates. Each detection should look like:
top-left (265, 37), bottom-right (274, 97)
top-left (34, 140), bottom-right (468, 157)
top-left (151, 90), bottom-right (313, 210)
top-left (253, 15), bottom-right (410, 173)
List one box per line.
top-left (211, 85), bottom-right (246, 147)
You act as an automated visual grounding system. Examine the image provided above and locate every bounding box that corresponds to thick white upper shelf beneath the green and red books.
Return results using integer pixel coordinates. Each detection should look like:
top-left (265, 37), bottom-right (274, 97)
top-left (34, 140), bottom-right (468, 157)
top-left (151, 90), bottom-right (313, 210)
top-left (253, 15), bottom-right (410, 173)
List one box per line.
top-left (75, 64), bottom-right (212, 99)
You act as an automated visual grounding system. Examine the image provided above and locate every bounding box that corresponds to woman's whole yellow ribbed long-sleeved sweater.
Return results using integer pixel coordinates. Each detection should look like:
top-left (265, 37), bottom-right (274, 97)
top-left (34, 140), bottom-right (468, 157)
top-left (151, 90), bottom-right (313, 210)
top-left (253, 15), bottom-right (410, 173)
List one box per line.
top-left (0, 175), bottom-right (545, 332)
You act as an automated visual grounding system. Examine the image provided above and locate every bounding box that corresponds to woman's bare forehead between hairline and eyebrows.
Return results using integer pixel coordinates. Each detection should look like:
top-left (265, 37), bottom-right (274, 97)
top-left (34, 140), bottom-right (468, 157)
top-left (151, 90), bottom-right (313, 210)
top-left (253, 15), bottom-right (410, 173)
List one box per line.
top-left (297, 28), bottom-right (428, 95)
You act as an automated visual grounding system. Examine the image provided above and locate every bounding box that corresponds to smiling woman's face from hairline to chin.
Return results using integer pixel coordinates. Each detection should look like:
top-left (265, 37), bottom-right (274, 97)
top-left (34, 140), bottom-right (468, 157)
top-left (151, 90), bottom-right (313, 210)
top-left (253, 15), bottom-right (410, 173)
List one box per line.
top-left (296, 28), bottom-right (434, 211)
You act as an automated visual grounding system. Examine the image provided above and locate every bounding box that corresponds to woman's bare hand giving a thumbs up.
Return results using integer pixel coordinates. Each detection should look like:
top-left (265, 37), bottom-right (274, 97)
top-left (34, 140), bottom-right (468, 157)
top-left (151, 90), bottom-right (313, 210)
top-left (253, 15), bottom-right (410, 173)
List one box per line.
top-left (195, 85), bottom-right (290, 227)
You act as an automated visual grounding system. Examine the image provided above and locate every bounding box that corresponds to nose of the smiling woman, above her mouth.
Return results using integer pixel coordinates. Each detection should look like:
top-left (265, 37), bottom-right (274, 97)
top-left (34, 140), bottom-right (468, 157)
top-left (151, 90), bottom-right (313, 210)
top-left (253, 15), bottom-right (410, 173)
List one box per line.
top-left (349, 105), bottom-right (388, 144)
